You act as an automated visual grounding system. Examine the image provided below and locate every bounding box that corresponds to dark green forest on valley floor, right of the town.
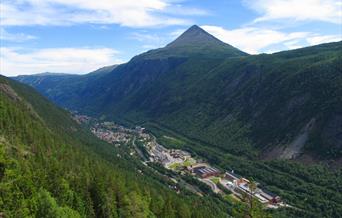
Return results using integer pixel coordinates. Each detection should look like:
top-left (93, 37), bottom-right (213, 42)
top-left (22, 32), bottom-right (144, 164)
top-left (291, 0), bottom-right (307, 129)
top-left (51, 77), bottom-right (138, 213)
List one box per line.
top-left (146, 123), bottom-right (342, 217)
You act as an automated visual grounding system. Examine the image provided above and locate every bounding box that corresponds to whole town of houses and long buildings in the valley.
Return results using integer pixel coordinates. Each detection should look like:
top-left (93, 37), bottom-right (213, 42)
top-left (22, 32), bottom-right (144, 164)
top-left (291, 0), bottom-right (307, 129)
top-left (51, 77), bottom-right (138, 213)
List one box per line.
top-left (74, 115), bottom-right (289, 208)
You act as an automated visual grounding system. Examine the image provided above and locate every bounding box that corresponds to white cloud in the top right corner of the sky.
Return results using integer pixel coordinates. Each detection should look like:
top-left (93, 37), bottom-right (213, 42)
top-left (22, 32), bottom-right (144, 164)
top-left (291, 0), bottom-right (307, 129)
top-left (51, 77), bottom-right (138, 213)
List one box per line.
top-left (245, 0), bottom-right (342, 24)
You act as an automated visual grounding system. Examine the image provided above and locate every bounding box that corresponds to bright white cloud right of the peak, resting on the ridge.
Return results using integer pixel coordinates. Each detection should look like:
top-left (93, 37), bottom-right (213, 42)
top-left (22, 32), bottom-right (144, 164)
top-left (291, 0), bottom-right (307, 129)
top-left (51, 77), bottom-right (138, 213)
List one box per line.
top-left (202, 26), bottom-right (342, 54)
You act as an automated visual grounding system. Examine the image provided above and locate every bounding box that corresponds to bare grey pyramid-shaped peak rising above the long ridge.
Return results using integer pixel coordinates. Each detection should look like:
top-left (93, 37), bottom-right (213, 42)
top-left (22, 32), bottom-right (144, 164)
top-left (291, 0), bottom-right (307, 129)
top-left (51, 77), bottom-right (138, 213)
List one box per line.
top-left (167, 25), bottom-right (225, 47)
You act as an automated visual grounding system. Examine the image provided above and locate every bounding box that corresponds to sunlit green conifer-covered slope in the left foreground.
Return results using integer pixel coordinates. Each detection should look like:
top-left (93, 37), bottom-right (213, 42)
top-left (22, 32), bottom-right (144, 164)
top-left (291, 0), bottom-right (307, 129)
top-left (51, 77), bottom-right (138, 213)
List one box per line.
top-left (0, 76), bottom-right (229, 218)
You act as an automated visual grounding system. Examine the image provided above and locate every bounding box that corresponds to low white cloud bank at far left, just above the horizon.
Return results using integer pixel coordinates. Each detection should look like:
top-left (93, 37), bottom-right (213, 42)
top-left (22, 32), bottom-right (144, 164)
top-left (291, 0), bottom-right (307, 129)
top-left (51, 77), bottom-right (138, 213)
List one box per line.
top-left (0, 47), bottom-right (122, 76)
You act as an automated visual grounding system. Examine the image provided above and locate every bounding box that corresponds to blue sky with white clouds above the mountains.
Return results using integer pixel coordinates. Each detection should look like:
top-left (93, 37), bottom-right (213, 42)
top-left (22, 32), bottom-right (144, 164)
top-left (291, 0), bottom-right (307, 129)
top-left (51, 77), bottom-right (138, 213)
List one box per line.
top-left (0, 0), bottom-right (342, 76)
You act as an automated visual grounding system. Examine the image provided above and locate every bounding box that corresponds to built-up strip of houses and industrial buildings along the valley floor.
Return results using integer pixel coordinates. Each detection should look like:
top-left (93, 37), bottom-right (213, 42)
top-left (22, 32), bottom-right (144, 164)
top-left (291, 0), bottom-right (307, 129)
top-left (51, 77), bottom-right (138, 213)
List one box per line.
top-left (78, 115), bottom-right (281, 207)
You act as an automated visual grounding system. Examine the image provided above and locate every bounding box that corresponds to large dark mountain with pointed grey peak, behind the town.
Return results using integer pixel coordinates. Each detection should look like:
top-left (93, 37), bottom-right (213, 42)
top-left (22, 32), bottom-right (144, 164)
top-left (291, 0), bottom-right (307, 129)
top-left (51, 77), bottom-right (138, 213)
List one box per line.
top-left (14, 26), bottom-right (342, 164)
